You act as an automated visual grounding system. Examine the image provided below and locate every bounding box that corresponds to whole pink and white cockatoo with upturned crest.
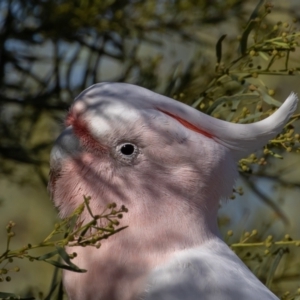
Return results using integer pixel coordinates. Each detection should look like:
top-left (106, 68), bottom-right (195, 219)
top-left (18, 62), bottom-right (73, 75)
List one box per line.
top-left (49, 83), bottom-right (297, 300)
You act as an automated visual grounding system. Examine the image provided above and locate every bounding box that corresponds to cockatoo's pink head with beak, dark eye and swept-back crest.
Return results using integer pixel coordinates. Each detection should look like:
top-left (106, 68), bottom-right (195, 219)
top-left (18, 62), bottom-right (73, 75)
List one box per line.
top-left (49, 83), bottom-right (296, 245)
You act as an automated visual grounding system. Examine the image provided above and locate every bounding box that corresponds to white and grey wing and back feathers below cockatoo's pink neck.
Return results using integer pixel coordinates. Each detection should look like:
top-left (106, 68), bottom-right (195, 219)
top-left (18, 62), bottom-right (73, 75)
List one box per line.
top-left (140, 238), bottom-right (278, 300)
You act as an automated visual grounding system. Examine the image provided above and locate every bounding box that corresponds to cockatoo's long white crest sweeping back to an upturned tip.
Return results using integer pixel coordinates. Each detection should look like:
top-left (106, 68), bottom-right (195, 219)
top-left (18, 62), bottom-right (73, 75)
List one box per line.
top-left (75, 83), bottom-right (298, 159)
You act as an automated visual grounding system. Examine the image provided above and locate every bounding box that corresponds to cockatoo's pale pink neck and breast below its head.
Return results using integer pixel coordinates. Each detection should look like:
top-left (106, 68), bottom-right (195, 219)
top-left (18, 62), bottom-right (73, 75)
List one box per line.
top-left (64, 164), bottom-right (219, 300)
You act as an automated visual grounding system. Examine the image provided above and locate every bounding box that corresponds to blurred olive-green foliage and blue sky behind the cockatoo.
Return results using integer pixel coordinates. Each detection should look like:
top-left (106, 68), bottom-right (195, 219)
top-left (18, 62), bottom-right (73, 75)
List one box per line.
top-left (0, 0), bottom-right (300, 299)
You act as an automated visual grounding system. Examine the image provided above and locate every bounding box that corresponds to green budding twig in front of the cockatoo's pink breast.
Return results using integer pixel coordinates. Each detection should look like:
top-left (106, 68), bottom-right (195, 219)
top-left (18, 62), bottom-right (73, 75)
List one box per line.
top-left (0, 197), bottom-right (128, 299)
